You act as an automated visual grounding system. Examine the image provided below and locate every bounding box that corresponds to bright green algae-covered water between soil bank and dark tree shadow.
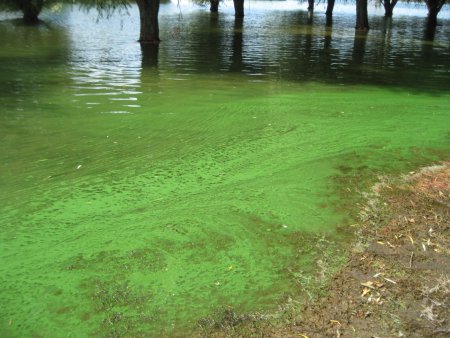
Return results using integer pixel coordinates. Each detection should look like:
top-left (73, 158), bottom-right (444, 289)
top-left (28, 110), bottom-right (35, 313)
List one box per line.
top-left (0, 3), bottom-right (450, 337)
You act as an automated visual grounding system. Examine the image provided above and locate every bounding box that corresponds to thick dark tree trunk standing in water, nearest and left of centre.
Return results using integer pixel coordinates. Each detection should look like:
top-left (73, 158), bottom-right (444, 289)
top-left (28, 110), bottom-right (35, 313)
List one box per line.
top-left (136, 0), bottom-right (160, 45)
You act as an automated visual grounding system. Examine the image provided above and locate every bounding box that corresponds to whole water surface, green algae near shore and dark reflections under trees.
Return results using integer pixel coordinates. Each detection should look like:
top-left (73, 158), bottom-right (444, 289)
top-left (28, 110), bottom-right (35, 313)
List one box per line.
top-left (0, 1), bottom-right (450, 337)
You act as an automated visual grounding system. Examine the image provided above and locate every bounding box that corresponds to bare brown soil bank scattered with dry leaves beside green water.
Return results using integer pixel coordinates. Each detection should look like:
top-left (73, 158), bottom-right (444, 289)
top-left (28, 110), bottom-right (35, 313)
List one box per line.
top-left (202, 162), bottom-right (450, 338)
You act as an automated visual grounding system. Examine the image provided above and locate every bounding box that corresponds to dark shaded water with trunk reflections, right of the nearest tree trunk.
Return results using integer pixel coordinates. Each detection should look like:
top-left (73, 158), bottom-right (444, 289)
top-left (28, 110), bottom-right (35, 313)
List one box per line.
top-left (156, 11), bottom-right (450, 94)
